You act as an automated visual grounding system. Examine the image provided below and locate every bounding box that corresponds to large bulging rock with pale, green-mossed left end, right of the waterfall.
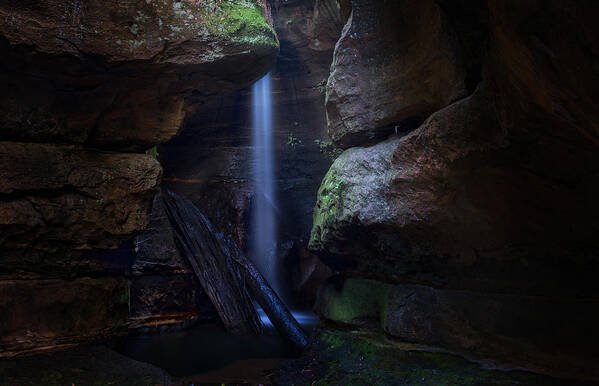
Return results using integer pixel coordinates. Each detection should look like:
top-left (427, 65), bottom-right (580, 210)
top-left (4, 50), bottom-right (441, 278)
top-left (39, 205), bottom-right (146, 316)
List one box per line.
top-left (311, 3), bottom-right (599, 296)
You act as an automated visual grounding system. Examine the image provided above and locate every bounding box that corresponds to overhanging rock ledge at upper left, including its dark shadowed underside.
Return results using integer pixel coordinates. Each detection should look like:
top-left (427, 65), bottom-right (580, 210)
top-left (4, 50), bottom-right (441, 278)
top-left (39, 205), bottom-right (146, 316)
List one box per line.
top-left (0, 0), bottom-right (278, 150)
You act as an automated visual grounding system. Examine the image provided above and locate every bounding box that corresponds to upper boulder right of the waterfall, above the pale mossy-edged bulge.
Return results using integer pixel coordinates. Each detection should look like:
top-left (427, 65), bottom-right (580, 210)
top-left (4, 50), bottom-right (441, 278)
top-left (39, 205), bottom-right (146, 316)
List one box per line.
top-left (326, 0), bottom-right (467, 148)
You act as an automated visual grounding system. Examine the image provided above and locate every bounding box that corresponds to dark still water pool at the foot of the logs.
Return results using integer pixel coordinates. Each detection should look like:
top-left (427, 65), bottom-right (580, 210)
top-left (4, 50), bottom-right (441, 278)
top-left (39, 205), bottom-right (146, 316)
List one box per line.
top-left (114, 310), bottom-right (318, 377)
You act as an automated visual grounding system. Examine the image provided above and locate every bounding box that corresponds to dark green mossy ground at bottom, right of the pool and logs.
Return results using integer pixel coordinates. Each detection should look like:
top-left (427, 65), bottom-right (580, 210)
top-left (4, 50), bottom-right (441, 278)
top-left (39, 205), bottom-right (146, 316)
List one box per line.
top-left (278, 330), bottom-right (578, 385)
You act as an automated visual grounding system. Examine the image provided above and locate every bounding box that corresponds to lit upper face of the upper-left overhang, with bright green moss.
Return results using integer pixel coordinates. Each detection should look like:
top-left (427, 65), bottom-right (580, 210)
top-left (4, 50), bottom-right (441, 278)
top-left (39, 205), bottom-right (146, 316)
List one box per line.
top-left (0, 0), bottom-right (276, 61)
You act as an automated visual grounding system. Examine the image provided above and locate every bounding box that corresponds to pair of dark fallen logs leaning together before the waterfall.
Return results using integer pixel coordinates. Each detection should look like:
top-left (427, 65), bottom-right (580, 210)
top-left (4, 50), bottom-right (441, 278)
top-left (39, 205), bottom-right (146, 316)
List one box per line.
top-left (163, 191), bottom-right (308, 348)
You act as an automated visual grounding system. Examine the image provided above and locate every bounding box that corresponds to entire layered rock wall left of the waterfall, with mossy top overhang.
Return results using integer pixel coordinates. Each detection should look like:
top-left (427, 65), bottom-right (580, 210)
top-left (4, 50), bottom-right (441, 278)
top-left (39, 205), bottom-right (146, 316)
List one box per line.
top-left (0, 0), bottom-right (278, 355)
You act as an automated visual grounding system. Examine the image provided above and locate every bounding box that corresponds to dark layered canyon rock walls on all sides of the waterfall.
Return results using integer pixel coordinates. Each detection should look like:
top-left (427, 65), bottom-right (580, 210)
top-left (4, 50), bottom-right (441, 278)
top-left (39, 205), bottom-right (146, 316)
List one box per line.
top-left (0, 0), bottom-right (599, 380)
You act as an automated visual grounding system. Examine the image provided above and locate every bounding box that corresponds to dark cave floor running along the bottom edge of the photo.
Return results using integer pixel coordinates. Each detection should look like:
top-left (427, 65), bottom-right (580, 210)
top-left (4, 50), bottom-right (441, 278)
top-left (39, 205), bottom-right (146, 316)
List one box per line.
top-left (0, 328), bottom-right (583, 386)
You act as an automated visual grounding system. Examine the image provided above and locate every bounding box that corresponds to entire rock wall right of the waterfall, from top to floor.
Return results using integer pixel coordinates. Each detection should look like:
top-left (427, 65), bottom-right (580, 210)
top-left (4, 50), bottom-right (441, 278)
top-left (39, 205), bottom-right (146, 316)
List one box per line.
top-left (310, 0), bottom-right (599, 380)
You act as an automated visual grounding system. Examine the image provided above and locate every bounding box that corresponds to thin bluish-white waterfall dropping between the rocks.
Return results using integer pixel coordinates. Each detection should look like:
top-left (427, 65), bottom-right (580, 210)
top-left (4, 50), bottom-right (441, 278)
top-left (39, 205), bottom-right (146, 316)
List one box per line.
top-left (250, 74), bottom-right (280, 294)
